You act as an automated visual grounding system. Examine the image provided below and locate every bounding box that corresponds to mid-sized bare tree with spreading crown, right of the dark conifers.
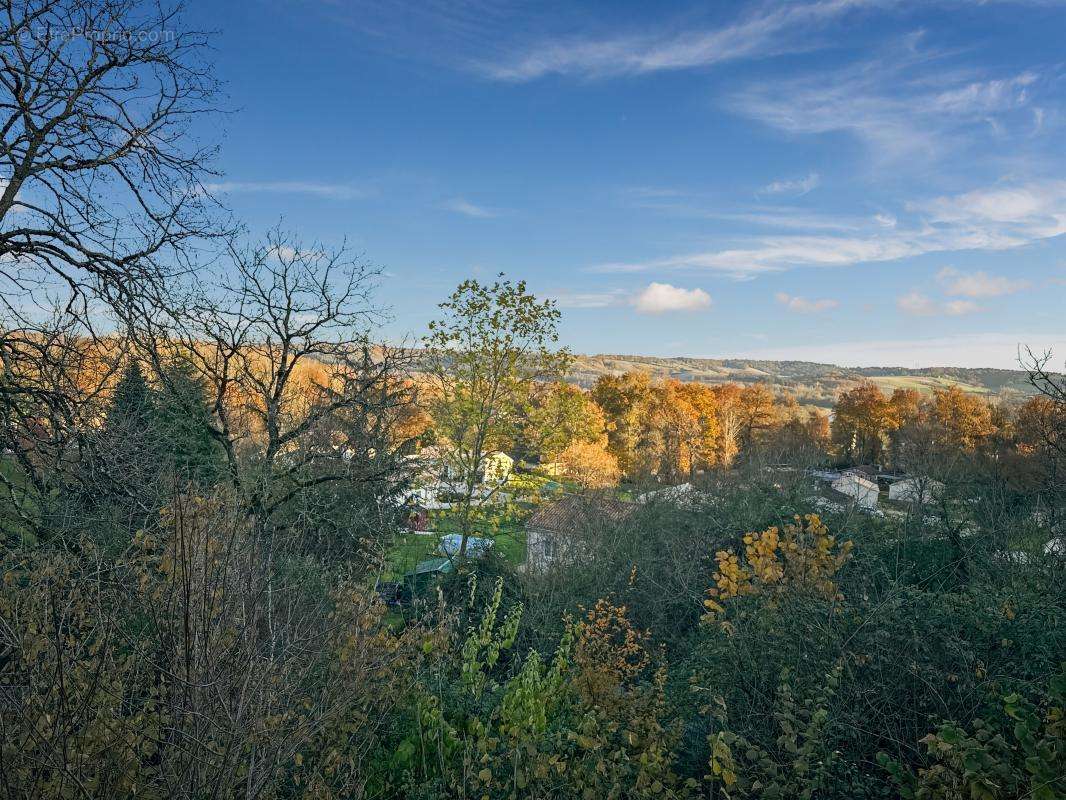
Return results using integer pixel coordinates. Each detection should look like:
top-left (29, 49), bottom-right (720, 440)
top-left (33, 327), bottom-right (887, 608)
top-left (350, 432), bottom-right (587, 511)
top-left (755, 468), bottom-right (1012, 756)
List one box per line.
top-left (127, 230), bottom-right (414, 541)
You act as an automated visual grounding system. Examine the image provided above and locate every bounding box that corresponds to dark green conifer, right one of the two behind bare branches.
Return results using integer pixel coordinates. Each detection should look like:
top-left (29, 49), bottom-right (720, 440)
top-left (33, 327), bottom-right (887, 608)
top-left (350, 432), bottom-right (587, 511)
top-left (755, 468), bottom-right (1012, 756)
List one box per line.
top-left (156, 362), bottom-right (225, 486)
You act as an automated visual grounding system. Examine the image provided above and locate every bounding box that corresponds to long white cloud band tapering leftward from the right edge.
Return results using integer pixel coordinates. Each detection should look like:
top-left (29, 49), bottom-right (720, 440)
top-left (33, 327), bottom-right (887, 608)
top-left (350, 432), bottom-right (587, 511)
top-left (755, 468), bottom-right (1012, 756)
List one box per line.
top-left (589, 180), bottom-right (1066, 278)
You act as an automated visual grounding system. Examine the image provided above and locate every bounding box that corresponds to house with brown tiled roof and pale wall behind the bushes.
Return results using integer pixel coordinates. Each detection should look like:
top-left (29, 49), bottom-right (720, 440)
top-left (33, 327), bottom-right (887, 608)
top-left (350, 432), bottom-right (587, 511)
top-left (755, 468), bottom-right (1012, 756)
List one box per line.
top-left (526, 495), bottom-right (637, 572)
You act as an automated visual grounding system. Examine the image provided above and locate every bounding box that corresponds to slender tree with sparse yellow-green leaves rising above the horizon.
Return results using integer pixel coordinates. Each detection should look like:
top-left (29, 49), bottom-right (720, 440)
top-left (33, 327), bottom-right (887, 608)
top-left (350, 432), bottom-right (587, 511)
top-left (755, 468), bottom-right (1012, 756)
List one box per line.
top-left (424, 274), bottom-right (569, 556)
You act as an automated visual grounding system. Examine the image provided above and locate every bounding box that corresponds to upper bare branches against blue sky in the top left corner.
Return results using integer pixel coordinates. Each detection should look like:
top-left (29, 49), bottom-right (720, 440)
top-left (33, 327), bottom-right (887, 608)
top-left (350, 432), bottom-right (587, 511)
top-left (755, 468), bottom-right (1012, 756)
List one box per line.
top-left (0, 0), bottom-right (216, 298)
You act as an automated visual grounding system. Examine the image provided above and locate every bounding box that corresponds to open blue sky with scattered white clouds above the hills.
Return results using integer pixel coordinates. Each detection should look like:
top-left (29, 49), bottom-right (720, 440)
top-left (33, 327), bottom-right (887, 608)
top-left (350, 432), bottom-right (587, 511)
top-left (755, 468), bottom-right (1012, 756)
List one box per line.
top-left (190, 0), bottom-right (1066, 367)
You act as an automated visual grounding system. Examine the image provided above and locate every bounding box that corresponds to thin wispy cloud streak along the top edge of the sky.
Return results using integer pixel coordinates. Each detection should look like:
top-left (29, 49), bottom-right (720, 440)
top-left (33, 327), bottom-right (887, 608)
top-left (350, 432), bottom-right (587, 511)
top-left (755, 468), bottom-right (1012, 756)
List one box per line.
top-left (475, 0), bottom-right (884, 82)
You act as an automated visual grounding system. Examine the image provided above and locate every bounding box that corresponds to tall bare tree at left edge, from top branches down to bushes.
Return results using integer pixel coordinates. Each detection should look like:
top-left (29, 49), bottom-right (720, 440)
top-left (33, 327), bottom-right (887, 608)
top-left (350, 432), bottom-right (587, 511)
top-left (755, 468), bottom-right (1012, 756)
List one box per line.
top-left (0, 0), bottom-right (221, 533)
